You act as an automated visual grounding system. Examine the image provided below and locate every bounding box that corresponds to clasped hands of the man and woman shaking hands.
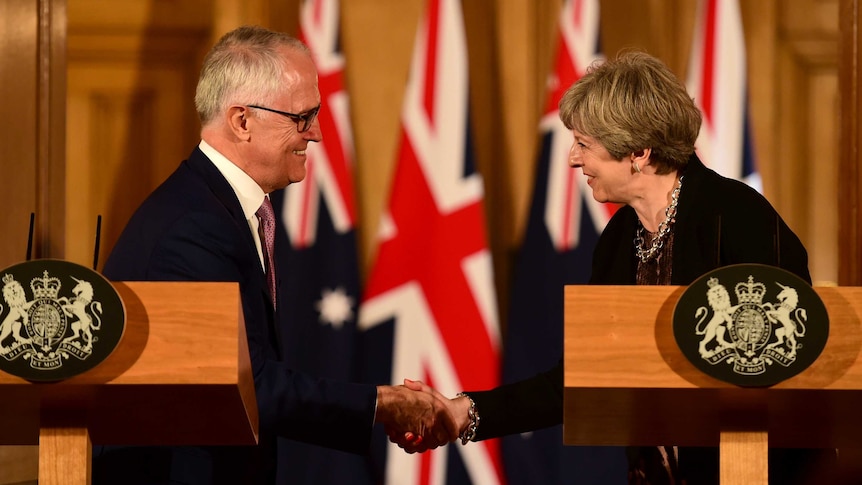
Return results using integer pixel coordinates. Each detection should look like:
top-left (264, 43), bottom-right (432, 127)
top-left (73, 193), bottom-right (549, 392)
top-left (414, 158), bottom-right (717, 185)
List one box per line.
top-left (374, 379), bottom-right (478, 453)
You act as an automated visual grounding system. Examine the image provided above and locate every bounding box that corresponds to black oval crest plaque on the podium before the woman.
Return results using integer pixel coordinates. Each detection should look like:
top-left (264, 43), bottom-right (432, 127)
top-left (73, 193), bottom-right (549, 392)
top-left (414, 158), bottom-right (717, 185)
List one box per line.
top-left (673, 264), bottom-right (829, 386)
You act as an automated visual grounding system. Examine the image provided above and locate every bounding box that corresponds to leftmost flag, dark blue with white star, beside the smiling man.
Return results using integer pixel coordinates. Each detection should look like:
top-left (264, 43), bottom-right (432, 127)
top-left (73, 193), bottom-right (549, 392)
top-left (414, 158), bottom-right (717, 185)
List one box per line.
top-left (272, 0), bottom-right (371, 485)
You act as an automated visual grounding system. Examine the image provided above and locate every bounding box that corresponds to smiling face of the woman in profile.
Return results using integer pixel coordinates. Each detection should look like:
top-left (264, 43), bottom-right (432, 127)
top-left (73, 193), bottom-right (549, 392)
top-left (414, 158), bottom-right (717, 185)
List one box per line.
top-left (569, 130), bottom-right (632, 204)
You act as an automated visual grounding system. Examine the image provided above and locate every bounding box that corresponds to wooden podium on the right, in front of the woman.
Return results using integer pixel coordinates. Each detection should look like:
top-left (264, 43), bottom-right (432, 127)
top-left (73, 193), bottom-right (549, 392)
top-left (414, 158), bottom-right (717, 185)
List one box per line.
top-left (563, 286), bottom-right (862, 485)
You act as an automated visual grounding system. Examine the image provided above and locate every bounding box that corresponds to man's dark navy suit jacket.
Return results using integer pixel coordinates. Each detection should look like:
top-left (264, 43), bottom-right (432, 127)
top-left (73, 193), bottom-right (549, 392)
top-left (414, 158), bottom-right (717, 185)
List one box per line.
top-left (93, 148), bottom-right (377, 484)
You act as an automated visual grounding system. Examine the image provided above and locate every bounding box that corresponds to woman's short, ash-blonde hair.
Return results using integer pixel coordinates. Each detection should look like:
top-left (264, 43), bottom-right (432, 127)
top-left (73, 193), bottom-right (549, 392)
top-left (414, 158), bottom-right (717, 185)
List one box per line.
top-left (559, 51), bottom-right (701, 174)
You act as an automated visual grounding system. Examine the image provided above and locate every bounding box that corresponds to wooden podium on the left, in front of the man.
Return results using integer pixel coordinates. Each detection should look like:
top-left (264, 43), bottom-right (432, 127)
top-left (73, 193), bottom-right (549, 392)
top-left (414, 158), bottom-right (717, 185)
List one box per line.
top-left (0, 282), bottom-right (258, 485)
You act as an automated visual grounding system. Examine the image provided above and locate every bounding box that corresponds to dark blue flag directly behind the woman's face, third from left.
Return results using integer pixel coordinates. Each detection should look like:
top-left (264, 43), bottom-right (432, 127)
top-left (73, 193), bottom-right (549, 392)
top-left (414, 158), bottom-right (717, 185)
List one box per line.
top-left (502, 0), bottom-right (628, 485)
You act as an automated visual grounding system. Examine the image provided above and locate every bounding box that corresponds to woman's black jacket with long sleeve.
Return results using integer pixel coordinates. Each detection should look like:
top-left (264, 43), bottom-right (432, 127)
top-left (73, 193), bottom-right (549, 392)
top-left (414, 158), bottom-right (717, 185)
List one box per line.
top-left (468, 155), bottom-right (811, 439)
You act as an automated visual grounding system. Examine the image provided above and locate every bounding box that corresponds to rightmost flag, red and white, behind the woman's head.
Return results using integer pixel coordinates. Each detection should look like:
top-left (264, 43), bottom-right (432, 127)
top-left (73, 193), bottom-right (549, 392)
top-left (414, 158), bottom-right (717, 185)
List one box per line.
top-left (687, 0), bottom-right (762, 192)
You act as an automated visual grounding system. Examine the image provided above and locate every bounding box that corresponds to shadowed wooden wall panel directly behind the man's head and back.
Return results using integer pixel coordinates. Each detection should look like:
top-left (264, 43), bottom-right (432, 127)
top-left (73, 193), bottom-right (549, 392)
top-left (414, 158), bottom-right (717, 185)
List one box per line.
top-left (65, 0), bottom-right (212, 267)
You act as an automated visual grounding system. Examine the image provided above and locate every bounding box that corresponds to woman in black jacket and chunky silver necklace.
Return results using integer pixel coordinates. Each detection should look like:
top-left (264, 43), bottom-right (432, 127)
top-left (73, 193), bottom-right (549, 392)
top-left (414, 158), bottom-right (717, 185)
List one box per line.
top-left (400, 52), bottom-right (832, 485)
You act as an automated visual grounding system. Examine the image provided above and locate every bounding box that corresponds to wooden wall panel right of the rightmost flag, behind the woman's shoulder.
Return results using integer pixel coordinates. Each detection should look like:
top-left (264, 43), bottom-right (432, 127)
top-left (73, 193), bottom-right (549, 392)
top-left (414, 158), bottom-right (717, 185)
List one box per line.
top-left (767, 0), bottom-right (839, 284)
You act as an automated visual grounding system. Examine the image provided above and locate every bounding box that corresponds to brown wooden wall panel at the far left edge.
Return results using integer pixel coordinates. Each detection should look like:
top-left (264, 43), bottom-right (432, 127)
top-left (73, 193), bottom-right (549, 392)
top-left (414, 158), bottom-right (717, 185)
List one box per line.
top-left (0, 0), bottom-right (66, 485)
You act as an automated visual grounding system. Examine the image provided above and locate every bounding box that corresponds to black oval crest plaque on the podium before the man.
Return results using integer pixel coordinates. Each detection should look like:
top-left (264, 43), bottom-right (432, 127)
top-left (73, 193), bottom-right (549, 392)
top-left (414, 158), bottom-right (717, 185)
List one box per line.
top-left (0, 260), bottom-right (125, 381)
